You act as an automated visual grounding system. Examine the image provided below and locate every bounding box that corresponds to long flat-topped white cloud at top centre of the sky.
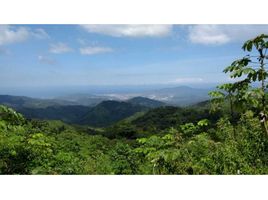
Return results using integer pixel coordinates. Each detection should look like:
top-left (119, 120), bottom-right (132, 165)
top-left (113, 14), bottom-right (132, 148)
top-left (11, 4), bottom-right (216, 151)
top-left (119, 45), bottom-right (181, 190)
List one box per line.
top-left (81, 24), bottom-right (172, 37)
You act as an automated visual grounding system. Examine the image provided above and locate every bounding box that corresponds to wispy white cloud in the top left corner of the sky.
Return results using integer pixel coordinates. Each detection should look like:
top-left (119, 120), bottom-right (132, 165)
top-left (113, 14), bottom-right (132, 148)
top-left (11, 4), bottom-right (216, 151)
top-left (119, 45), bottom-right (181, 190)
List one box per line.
top-left (0, 25), bottom-right (49, 45)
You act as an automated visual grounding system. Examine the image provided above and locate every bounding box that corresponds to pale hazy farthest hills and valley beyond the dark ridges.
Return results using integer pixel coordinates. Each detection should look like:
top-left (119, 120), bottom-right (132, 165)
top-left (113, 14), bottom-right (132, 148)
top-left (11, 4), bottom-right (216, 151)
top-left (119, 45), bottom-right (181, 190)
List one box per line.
top-left (57, 86), bottom-right (213, 106)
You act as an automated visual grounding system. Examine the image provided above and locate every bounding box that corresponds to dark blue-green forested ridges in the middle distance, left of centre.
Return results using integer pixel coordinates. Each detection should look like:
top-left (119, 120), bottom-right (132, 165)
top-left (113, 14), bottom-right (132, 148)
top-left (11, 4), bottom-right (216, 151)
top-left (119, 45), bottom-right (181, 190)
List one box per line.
top-left (0, 95), bottom-right (164, 127)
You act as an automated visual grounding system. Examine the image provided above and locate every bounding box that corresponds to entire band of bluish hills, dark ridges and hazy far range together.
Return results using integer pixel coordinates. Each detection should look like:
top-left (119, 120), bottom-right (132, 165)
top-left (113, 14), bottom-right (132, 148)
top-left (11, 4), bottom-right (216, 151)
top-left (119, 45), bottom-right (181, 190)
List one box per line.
top-left (0, 87), bottom-right (213, 127)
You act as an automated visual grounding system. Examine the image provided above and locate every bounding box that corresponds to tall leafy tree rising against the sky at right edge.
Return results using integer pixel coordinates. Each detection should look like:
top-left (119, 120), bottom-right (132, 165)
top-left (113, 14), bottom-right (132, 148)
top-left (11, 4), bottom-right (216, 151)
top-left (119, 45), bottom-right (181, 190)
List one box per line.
top-left (211, 34), bottom-right (268, 135)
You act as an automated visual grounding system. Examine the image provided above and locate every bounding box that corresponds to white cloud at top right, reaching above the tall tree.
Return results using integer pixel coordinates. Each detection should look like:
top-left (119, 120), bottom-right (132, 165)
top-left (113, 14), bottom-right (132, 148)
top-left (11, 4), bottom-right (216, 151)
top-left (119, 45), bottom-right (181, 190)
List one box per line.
top-left (188, 25), bottom-right (268, 45)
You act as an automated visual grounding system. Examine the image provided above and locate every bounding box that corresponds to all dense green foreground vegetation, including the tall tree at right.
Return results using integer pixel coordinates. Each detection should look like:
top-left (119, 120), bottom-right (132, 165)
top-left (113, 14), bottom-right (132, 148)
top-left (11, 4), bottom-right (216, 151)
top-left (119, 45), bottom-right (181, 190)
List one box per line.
top-left (0, 35), bottom-right (268, 174)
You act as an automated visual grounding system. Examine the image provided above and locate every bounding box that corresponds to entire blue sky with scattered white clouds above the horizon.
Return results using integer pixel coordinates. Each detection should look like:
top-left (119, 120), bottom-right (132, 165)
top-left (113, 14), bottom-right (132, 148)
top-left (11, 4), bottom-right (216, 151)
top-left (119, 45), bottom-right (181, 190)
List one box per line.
top-left (0, 25), bottom-right (268, 87)
